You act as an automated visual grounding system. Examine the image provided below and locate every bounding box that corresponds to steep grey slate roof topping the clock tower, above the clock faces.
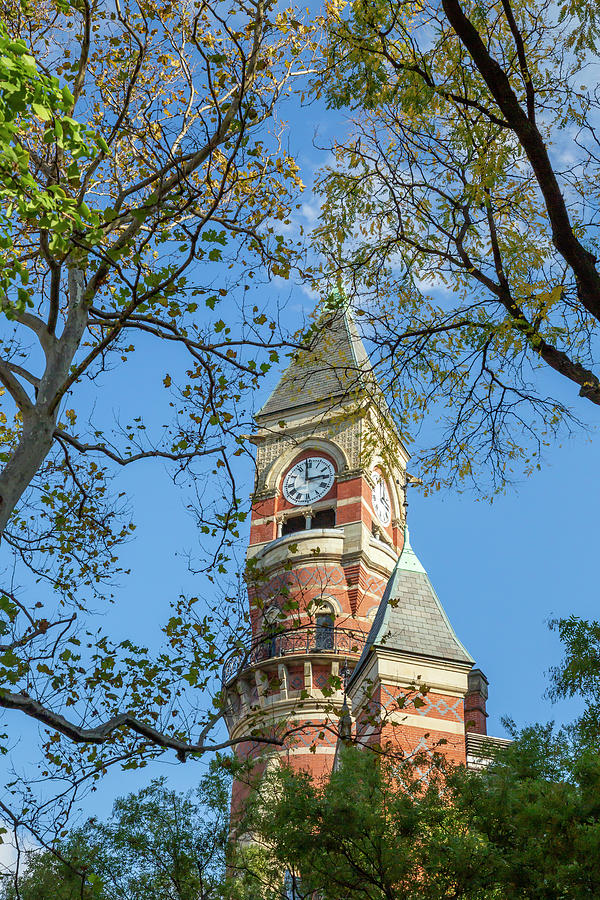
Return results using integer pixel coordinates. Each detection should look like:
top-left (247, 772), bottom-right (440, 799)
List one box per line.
top-left (256, 303), bottom-right (373, 422)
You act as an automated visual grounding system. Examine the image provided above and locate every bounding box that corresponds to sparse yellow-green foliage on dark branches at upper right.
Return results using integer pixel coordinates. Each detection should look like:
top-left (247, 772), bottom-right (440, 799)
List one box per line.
top-left (315, 0), bottom-right (600, 488)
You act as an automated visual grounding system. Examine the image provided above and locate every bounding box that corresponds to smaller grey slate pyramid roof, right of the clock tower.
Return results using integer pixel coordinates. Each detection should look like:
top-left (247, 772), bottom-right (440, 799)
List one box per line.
top-left (349, 528), bottom-right (474, 684)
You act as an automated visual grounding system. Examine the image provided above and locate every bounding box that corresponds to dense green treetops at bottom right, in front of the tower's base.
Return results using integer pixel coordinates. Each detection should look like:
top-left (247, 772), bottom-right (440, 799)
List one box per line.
top-left (243, 726), bottom-right (600, 900)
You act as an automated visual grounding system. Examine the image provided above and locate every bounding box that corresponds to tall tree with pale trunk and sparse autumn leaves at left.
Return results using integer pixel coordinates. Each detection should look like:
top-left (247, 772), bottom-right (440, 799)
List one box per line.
top-left (0, 0), bottom-right (313, 841)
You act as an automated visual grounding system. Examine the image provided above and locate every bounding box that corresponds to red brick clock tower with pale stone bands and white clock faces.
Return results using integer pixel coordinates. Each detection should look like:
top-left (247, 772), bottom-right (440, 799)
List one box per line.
top-left (223, 307), bottom-right (485, 815)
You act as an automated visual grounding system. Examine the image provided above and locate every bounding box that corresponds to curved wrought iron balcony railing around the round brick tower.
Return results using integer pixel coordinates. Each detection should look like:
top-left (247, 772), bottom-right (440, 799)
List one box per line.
top-left (223, 625), bottom-right (367, 684)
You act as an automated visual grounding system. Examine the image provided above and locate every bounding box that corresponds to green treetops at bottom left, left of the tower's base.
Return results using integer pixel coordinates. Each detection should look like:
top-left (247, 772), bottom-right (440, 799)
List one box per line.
top-left (0, 768), bottom-right (230, 900)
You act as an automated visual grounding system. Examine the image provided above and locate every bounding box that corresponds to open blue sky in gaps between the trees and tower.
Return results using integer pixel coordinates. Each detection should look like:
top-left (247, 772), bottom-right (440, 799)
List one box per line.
top-left (75, 61), bottom-right (600, 811)
